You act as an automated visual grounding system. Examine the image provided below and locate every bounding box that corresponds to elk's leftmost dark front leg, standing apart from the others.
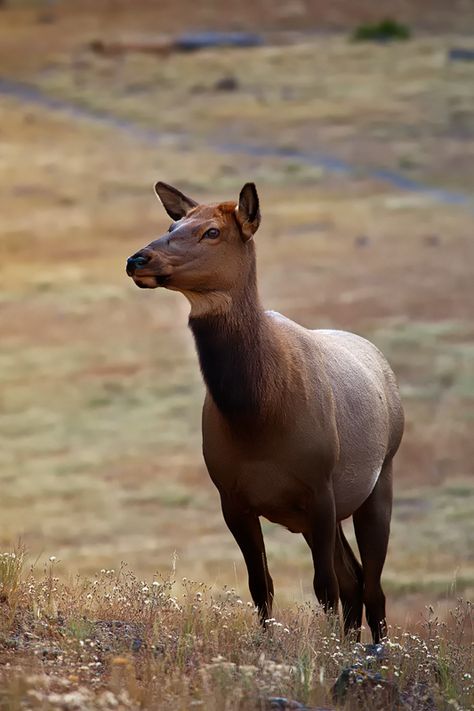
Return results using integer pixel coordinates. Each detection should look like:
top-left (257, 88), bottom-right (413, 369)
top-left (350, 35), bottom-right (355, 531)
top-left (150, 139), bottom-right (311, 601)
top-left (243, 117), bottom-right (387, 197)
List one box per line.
top-left (221, 498), bottom-right (273, 627)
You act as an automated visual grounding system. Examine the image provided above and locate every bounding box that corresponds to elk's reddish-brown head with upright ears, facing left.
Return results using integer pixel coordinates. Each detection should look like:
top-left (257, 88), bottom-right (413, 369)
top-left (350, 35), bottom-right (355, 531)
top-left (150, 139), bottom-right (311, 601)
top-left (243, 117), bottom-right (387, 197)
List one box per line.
top-left (127, 182), bottom-right (260, 310)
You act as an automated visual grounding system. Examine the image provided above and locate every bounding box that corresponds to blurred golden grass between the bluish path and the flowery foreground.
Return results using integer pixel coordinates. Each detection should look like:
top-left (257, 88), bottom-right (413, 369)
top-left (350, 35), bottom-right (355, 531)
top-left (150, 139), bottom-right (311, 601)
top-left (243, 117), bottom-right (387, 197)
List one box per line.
top-left (0, 93), bottom-right (474, 608)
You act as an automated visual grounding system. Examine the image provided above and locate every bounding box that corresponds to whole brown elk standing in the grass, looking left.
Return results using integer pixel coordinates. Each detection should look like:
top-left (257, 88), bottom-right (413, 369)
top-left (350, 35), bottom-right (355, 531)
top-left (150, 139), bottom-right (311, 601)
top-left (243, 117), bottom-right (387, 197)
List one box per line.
top-left (127, 182), bottom-right (403, 642)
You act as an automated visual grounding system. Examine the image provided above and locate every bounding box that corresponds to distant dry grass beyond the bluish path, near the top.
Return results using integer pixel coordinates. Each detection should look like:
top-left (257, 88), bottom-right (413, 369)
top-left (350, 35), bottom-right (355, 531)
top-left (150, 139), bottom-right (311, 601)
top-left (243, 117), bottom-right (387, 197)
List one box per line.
top-left (0, 8), bottom-right (474, 193)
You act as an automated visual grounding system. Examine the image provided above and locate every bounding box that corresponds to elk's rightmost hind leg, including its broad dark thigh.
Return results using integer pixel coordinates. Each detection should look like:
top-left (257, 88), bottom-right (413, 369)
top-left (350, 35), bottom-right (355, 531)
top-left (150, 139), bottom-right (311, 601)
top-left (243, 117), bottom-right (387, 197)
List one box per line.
top-left (353, 460), bottom-right (392, 643)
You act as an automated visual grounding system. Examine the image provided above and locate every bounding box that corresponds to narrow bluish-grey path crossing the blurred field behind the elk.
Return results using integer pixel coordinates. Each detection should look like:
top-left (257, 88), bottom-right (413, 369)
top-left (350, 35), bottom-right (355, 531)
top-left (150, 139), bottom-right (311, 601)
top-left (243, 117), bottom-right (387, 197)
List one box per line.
top-left (0, 78), bottom-right (474, 212)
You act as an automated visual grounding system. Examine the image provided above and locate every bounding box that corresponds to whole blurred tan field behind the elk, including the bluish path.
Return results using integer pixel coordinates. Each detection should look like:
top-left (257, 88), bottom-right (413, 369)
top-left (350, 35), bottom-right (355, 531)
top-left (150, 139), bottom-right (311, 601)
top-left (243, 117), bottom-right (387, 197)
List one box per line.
top-left (0, 0), bottom-right (474, 623)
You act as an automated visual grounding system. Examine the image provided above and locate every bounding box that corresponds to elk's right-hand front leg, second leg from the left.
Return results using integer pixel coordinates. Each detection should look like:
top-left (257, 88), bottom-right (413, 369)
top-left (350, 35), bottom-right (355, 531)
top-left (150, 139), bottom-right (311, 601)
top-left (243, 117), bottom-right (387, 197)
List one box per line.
top-left (305, 490), bottom-right (339, 613)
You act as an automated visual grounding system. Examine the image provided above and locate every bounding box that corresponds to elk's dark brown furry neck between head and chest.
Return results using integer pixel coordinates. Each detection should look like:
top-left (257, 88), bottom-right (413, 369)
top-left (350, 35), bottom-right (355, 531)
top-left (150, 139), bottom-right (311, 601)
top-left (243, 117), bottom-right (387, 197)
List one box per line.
top-left (189, 263), bottom-right (278, 419)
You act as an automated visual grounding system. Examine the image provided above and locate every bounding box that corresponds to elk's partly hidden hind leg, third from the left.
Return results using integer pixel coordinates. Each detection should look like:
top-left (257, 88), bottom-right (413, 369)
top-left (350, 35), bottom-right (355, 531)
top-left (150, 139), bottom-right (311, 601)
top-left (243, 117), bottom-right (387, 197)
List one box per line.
top-left (334, 523), bottom-right (363, 641)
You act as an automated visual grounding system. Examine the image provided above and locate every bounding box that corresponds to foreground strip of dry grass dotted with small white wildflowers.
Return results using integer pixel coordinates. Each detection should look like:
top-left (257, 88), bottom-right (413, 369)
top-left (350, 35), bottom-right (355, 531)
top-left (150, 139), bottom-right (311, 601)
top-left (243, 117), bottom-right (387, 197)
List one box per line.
top-left (0, 558), bottom-right (474, 711)
